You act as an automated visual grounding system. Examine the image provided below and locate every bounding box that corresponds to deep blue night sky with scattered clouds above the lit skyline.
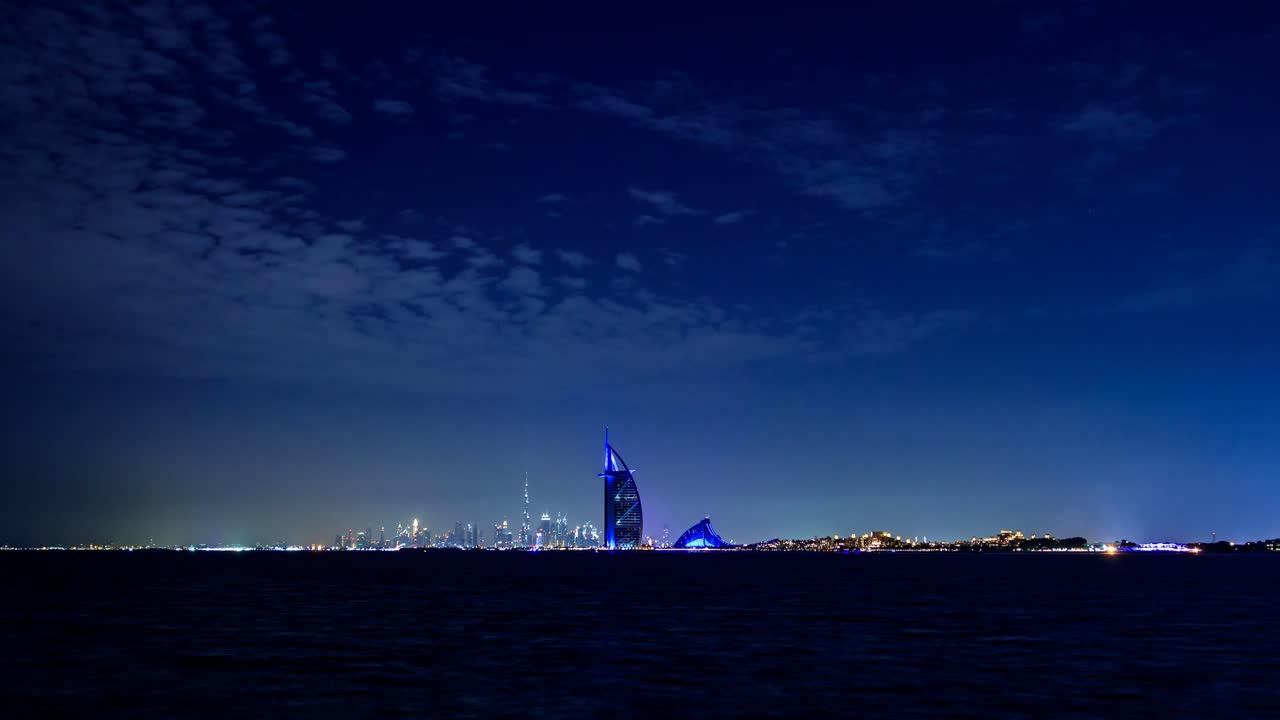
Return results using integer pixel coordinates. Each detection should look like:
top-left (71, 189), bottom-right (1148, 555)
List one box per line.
top-left (0, 0), bottom-right (1280, 544)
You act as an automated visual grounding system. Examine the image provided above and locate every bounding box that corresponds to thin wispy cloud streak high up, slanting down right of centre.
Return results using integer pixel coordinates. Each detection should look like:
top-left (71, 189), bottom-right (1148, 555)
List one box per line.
top-left (419, 56), bottom-right (951, 212)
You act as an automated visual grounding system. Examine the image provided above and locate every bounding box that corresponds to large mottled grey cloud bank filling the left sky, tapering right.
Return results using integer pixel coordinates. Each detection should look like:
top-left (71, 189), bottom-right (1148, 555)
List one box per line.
top-left (0, 0), bottom-right (977, 404)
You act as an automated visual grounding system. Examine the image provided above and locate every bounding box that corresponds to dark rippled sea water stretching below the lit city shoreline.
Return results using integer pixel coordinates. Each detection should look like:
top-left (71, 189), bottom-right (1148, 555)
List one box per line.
top-left (0, 552), bottom-right (1280, 720)
